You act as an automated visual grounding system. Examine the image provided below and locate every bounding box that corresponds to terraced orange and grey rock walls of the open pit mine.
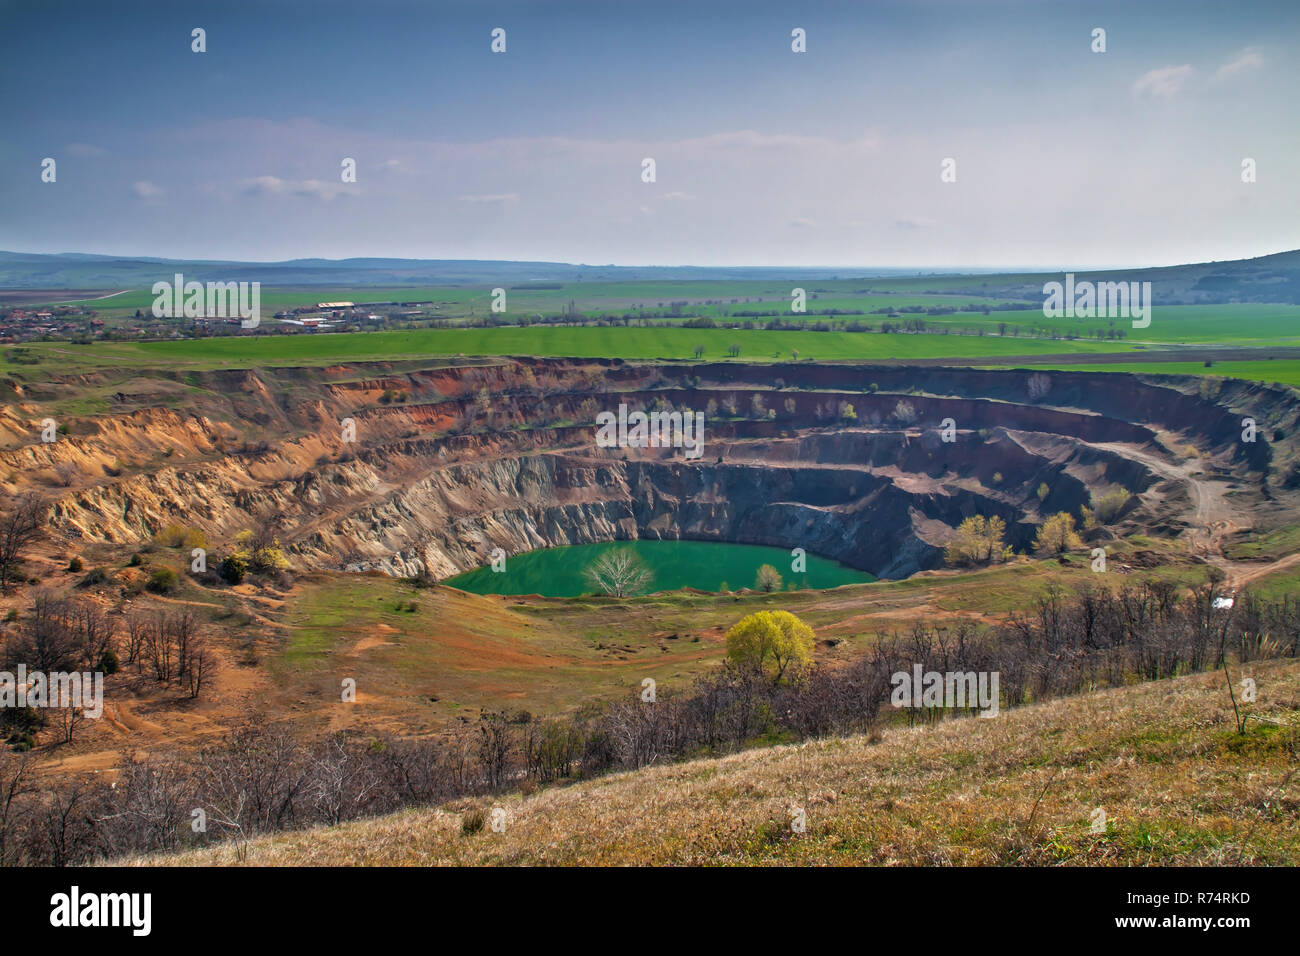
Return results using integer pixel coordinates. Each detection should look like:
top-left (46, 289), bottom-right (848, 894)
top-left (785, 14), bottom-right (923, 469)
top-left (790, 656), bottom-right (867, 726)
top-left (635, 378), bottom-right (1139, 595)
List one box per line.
top-left (0, 360), bottom-right (1300, 578)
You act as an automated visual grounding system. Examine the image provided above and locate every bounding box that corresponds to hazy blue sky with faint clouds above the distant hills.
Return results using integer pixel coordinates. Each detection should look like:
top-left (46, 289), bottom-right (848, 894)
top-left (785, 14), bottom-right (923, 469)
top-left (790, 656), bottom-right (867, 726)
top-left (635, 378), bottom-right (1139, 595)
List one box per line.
top-left (0, 0), bottom-right (1300, 268)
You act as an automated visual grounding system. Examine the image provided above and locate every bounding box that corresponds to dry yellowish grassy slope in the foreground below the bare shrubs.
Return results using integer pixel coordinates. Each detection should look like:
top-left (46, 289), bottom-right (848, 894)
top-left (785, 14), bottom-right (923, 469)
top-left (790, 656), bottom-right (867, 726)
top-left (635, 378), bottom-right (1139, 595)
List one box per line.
top-left (130, 661), bottom-right (1300, 866)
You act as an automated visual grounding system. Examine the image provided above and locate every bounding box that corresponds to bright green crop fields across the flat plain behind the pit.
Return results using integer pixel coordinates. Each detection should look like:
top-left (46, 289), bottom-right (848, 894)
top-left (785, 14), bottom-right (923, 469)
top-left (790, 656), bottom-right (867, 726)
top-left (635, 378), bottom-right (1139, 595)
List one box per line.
top-left (12, 276), bottom-right (1300, 385)
